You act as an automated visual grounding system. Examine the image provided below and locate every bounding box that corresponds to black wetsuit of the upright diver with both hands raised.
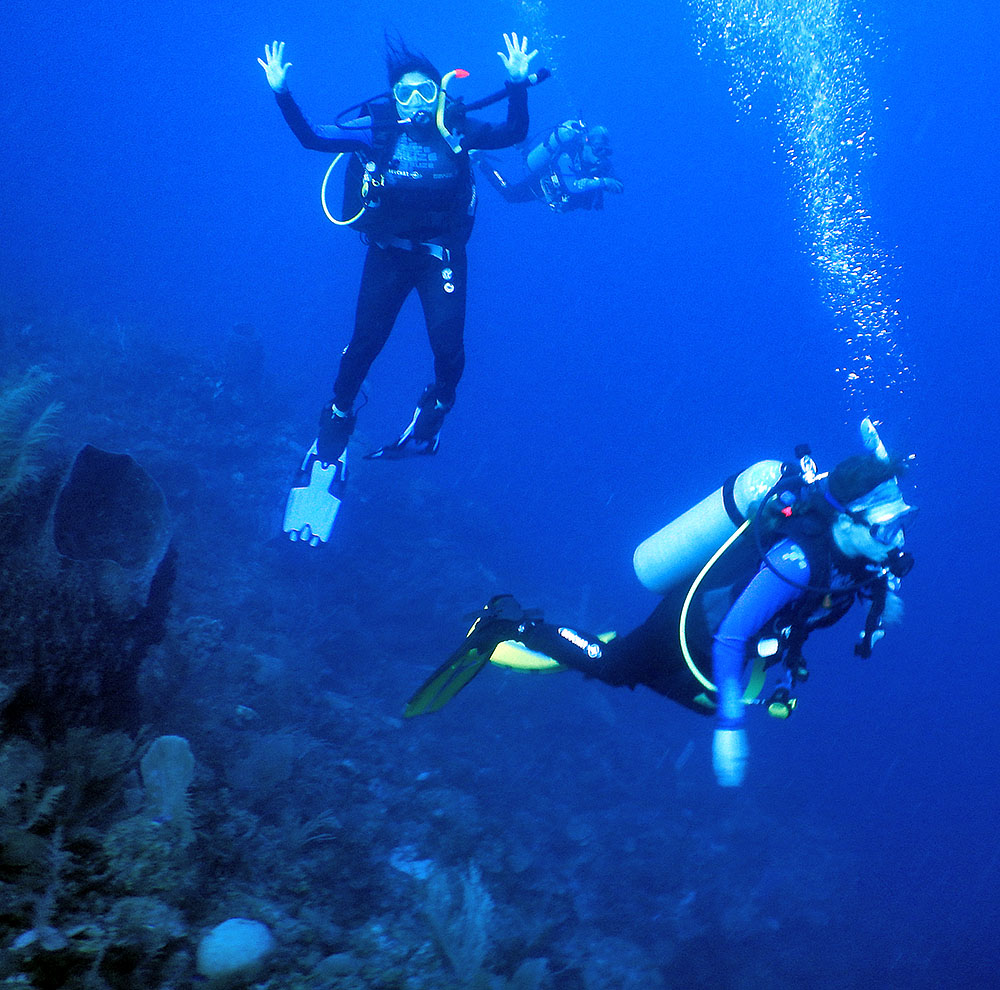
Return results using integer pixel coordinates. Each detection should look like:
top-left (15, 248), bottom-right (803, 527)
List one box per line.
top-left (275, 82), bottom-right (528, 411)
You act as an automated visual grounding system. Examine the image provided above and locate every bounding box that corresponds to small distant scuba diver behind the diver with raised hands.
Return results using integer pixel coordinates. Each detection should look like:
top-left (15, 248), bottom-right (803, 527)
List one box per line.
top-left (474, 120), bottom-right (625, 213)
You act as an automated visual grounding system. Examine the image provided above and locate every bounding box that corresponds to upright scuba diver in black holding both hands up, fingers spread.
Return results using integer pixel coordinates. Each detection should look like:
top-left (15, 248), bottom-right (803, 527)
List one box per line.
top-left (257, 34), bottom-right (538, 464)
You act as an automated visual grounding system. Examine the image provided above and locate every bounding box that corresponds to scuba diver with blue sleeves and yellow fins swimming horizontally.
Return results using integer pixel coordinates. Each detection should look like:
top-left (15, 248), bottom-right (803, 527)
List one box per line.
top-left (405, 419), bottom-right (916, 787)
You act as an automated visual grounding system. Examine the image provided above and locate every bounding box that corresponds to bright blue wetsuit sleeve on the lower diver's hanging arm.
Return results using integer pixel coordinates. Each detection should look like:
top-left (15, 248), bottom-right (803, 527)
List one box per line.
top-left (712, 540), bottom-right (809, 729)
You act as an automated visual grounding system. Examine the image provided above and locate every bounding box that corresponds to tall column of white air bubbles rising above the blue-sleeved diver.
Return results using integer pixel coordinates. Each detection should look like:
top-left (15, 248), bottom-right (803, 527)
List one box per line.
top-left (691, 0), bottom-right (913, 412)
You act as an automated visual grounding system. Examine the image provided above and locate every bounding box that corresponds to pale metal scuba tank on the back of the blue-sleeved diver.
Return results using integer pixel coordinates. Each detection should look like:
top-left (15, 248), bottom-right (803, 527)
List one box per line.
top-left (632, 460), bottom-right (782, 595)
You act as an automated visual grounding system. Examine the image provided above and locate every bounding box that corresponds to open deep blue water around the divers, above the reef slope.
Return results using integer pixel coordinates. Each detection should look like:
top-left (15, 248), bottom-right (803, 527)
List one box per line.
top-left (0, 0), bottom-right (1000, 986)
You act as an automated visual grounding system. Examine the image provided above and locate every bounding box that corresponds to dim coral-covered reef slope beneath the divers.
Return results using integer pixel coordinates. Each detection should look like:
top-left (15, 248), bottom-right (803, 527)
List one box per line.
top-left (0, 312), bottom-right (904, 990)
